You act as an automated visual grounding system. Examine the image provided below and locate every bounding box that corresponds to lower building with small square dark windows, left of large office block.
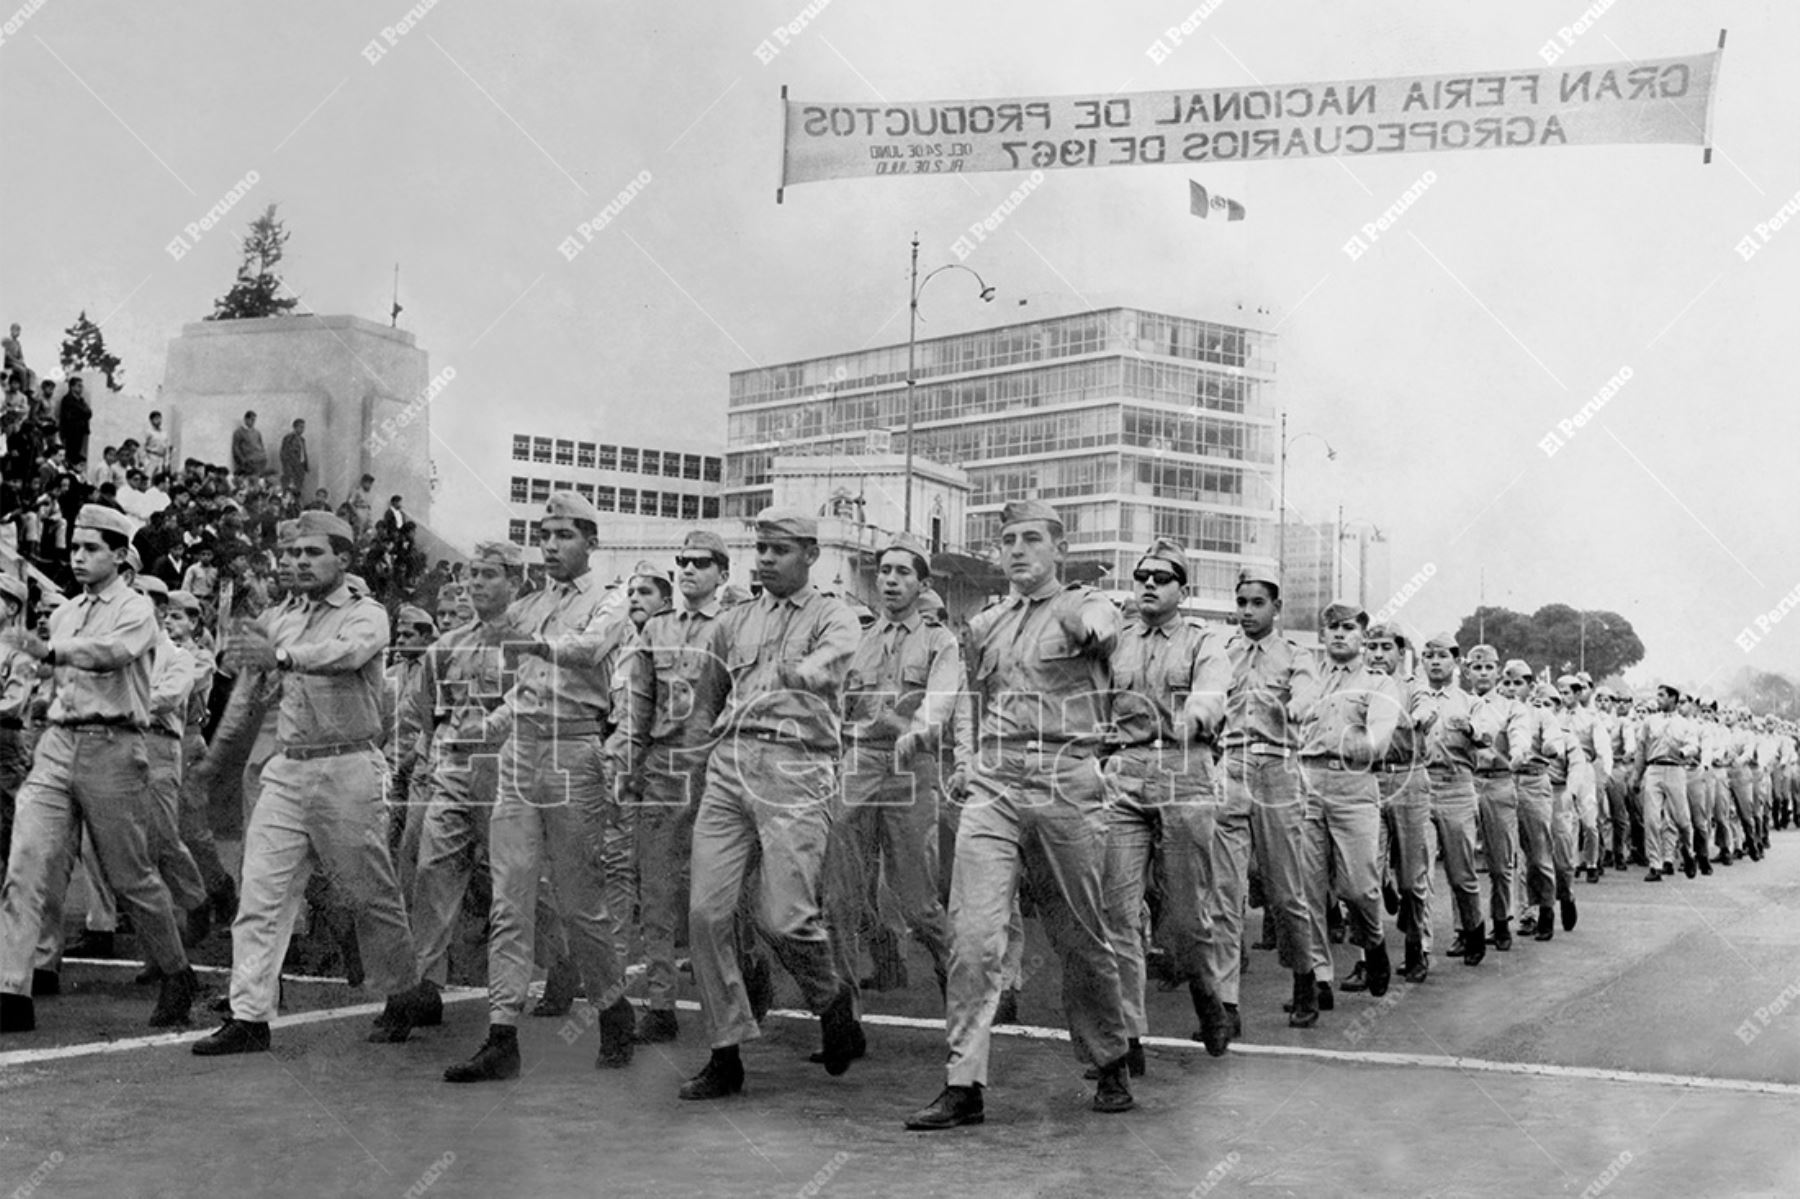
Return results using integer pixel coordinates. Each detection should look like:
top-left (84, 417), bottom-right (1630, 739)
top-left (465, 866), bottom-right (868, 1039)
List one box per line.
top-left (508, 432), bottom-right (724, 545)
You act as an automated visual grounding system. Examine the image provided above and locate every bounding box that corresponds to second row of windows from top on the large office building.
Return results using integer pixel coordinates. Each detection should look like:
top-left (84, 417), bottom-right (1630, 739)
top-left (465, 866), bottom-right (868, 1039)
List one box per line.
top-left (725, 358), bottom-right (1273, 448)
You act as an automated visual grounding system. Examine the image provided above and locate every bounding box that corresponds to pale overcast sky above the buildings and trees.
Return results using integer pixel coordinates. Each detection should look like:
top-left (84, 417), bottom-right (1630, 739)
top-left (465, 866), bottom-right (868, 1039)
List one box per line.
top-left (0, 0), bottom-right (1800, 684)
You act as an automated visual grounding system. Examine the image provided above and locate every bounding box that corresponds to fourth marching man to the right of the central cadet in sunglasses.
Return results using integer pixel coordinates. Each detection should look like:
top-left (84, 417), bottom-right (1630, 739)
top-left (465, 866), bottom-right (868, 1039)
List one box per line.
top-left (1411, 634), bottom-right (1483, 965)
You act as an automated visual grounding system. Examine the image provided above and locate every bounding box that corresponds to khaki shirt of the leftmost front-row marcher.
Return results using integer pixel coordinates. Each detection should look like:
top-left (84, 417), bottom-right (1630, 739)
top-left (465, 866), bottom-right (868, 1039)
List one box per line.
top-left (49, 576), bottom-right (160, 727)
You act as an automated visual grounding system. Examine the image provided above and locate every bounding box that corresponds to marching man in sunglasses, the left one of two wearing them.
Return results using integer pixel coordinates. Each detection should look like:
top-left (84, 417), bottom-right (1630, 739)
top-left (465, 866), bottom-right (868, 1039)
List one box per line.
top-left (619, 529), bottom-right (731, 1042)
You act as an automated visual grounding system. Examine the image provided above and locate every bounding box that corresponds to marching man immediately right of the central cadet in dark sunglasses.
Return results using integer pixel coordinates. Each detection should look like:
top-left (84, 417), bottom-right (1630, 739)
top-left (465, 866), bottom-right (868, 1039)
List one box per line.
top-left (1210, 567), bottom-right (1330, 1041)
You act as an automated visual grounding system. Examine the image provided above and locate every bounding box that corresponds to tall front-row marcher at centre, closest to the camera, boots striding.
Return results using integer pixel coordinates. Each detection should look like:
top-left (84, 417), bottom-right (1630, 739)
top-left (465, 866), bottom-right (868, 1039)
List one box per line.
top-left (905, 500), bottom-right (1134, 1131)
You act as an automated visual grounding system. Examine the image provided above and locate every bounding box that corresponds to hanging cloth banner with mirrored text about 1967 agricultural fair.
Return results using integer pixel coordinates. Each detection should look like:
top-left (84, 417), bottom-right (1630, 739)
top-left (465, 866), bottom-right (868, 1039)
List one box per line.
top-left (781, 50), bottom-right (1723, 187)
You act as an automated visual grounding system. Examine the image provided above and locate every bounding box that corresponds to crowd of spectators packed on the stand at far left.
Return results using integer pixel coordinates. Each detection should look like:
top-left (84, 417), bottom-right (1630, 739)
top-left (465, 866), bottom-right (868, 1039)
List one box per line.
top-left (0, 326), bottom-right (441, 616)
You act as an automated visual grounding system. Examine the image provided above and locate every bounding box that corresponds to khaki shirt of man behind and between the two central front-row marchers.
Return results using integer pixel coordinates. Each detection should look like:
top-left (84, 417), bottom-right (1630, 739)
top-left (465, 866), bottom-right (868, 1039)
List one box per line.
top-left (844, 610), bottom-right (963, 749)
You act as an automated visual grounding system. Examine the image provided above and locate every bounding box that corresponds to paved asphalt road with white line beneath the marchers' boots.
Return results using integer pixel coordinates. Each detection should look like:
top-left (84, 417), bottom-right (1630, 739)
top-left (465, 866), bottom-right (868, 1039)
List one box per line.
top-left (0, 832), bottom-right (1800, 1199)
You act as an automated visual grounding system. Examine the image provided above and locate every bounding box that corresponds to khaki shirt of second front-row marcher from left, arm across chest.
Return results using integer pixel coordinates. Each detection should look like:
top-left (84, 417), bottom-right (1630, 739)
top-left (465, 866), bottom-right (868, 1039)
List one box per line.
top-left (256, 583), bottom-right (387, 745)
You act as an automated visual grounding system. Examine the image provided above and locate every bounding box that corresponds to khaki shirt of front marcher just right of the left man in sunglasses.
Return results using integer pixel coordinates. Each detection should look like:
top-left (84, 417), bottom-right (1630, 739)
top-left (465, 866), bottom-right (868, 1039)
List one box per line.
top-left (704, 583), bottom-right (862, 754)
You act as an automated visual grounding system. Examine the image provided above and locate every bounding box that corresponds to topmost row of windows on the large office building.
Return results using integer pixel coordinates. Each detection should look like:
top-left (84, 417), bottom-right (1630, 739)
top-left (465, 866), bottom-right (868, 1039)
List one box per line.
top-left (729, 308), bottom-right (1274, 407)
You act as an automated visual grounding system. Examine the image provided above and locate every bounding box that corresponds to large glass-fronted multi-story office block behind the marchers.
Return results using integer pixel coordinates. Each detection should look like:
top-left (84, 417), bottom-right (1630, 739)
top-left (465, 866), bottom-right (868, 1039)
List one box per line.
top-left (724, 308), bottom-right (1278, 616)
